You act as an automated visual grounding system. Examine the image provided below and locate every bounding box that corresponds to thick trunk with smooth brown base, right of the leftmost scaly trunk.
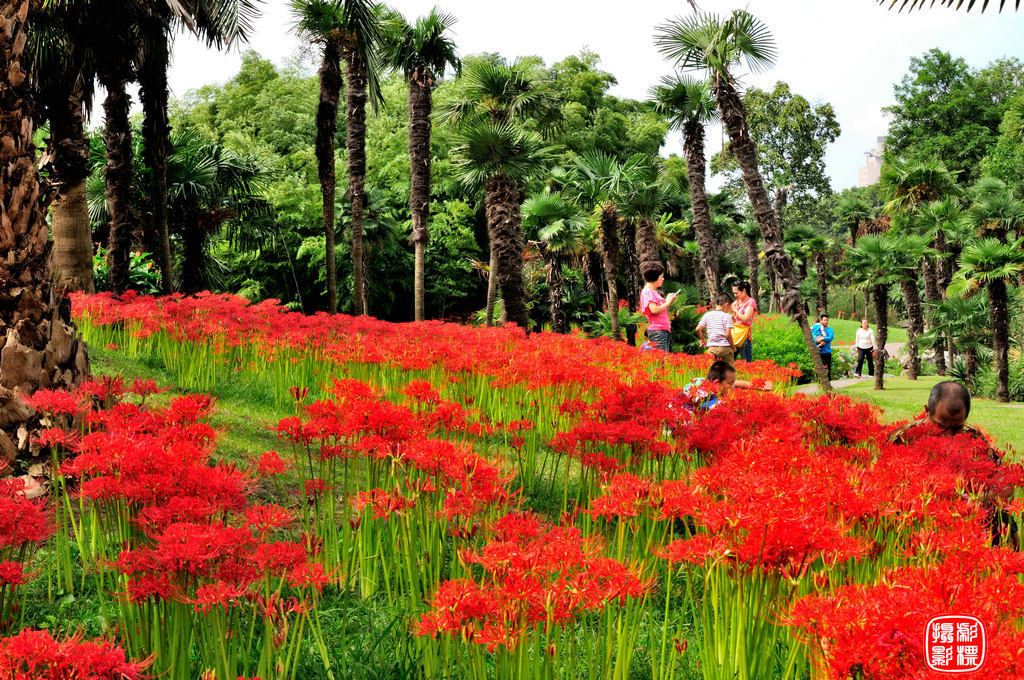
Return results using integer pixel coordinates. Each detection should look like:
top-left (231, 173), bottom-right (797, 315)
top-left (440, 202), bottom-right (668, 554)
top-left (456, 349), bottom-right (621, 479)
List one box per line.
top-left (49, 85), bottom-right (96, 293)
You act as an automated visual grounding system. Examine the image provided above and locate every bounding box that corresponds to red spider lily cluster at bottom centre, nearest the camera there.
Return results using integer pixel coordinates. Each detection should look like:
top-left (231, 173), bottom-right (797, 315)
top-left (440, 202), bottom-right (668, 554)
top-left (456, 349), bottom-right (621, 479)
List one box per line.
top-left (417, 513), bottom-right (650, 651)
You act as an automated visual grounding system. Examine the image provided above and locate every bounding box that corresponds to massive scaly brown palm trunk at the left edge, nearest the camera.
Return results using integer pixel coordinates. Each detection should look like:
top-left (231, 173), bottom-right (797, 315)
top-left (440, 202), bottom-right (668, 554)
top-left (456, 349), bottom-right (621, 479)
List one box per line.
top-left (0, 0), bottom-right (89, 456)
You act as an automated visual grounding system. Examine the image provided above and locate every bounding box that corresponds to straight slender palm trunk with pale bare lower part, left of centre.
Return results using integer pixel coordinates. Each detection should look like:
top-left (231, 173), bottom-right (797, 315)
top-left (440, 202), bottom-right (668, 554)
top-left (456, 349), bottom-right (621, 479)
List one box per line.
top-left (409, 71), bottom-right (433, 322)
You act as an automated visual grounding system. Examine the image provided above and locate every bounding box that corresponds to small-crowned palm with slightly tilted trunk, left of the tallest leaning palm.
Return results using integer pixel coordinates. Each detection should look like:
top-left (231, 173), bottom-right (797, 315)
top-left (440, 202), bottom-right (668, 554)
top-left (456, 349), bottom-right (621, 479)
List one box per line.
top-left (651, 76), bottom-right (721, 300)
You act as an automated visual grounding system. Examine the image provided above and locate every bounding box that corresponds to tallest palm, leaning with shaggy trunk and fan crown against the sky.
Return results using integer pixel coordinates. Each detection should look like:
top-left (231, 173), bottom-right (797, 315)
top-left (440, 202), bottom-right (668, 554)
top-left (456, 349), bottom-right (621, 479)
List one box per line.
top-left (656, 10), bottom-right (831, 391)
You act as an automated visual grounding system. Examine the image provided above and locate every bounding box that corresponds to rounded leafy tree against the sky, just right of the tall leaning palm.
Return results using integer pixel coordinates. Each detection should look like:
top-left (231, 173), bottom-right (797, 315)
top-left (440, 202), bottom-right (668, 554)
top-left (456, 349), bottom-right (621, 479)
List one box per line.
top-left (712, 82), bottom-right (840, 223)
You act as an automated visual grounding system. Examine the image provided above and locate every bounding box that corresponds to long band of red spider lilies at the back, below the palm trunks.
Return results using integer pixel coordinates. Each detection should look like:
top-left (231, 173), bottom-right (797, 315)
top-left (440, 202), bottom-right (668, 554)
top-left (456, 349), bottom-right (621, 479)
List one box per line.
top-left (73, 293), bottom-right (798, 389)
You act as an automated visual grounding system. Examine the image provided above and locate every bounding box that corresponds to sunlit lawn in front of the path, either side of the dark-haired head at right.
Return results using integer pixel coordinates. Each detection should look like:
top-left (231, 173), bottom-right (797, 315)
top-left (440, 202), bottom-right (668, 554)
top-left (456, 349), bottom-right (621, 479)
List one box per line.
top-left (840, 376), bottom-right (1024, 455)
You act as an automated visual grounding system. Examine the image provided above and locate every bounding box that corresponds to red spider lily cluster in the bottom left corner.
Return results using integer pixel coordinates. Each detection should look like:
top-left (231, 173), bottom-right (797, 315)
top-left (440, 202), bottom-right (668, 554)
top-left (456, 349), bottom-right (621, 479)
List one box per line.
top-left (0, 630), bottom-right (147, 680)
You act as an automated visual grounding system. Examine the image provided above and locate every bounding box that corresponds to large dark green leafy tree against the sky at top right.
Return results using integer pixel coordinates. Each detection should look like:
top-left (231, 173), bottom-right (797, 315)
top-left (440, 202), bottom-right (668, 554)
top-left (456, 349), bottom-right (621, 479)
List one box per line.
top-left (886, 48), bottom-right (1024, 182)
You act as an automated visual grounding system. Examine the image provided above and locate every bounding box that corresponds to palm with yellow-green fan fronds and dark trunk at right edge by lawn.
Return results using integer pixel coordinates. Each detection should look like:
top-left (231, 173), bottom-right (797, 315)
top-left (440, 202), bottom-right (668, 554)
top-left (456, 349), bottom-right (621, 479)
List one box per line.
top-left (949, 237), bottom-right (1024, 401)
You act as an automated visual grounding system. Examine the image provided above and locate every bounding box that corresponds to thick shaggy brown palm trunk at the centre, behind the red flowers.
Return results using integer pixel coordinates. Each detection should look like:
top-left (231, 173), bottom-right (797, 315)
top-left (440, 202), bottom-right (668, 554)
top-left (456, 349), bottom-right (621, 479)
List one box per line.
top-left (484, 175), bottom-right (529, 333)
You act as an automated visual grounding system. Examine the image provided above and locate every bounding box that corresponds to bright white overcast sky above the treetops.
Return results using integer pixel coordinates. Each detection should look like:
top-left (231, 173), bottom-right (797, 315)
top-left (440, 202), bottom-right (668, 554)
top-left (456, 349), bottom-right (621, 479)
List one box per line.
top-left (163, 0), bottom-right (1024, 190)
